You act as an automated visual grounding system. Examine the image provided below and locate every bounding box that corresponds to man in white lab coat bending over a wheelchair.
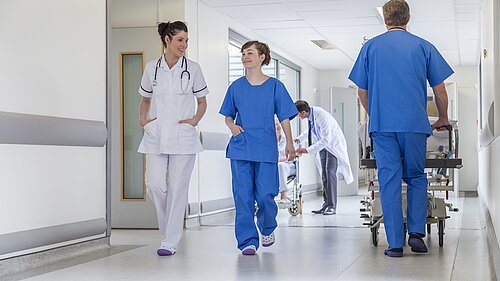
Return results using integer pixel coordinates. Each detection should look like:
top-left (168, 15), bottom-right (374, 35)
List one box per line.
top-left (295, 100), bottom-right (354, 215)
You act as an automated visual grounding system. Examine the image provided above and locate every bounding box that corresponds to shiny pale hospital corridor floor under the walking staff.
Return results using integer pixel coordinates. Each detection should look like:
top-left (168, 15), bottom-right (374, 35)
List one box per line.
top-left (0, 191), bottom-right (496, 281)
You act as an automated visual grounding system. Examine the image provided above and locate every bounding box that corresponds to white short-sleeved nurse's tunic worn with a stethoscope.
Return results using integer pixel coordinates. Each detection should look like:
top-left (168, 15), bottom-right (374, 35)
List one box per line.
top-left (138, 56), bottom-right (208, 154)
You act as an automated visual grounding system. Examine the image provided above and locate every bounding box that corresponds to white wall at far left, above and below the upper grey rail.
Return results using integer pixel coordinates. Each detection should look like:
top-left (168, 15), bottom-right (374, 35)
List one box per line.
top-left (0, 0), bottom-right (106, 254)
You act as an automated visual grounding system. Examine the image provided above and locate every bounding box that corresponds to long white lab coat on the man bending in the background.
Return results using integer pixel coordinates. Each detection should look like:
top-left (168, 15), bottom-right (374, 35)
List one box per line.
top-left (298, 106), bottom-right (354, 184)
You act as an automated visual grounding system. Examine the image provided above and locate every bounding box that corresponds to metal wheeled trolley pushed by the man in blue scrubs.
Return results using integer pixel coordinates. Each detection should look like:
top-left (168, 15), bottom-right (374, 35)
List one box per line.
top-left (360, 125), bottom-right (462, 247)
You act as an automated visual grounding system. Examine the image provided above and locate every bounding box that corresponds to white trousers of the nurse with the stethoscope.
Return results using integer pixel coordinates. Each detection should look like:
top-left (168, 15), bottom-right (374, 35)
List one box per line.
top-left (146, 154), bottom-right (196, 248)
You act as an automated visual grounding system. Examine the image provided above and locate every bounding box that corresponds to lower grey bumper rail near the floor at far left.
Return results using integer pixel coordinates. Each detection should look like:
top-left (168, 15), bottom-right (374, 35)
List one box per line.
top-left (0, 219), bottom-right (107, 255)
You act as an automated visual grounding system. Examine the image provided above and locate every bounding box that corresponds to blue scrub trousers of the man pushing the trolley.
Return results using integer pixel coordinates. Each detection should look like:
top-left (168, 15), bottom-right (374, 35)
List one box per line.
top-left (371, 132), bottom-right (427, 248)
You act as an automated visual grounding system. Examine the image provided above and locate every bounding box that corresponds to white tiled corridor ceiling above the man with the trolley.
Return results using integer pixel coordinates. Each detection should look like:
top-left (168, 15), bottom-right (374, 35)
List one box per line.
top-left (202, 0), bottom-right (480, 70)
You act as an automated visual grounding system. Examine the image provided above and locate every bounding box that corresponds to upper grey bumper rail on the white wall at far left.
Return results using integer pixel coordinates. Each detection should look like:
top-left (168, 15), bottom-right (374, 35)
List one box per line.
top-left (0, 112), bottom-right (108, 147)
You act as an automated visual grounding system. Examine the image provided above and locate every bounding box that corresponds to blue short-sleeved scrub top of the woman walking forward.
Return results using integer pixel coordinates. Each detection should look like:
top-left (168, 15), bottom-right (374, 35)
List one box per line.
top-left (219, 76), bottom-right (298, 163)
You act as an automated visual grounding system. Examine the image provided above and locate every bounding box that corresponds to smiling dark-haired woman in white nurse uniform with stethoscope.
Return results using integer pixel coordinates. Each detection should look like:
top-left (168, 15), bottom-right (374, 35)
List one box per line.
top-left (138, 21), bottom-right (208, 256)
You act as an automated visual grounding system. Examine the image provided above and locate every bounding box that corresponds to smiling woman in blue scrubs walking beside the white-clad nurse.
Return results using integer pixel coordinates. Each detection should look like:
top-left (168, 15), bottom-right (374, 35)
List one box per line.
top-left (219, 41), bottom-right (298, 255)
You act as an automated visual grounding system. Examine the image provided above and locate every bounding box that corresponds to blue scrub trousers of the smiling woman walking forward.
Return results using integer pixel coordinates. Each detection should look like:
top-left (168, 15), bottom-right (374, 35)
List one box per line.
top-left (231, 159), bottom-right (279, 250)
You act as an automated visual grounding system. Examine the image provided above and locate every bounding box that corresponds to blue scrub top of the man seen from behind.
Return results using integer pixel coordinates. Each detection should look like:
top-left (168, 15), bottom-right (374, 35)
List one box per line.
top-left (349, 30), bottom-right (453, 135)
